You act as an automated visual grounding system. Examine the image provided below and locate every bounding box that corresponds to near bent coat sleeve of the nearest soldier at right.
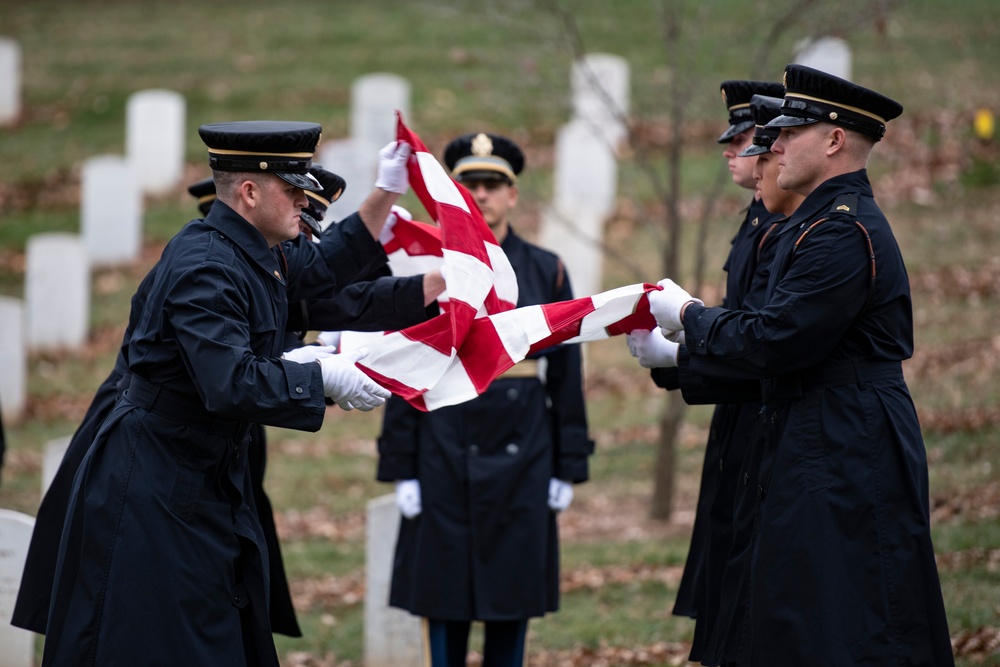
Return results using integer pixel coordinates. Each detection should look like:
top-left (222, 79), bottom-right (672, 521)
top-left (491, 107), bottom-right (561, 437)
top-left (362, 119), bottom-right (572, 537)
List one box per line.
top-left (684, 220), bottom-right (870, 377)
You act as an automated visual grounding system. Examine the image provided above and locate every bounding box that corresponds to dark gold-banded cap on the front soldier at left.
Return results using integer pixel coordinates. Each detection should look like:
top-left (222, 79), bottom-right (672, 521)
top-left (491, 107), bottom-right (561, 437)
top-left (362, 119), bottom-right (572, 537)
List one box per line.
top-left (198, 120), bottom-right (323, 192)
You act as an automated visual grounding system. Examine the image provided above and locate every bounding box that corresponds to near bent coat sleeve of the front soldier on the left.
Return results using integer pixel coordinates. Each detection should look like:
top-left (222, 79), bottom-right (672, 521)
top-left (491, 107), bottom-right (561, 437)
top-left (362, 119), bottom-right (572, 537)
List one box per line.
top-left (164, 261), bottom-right (326, 431)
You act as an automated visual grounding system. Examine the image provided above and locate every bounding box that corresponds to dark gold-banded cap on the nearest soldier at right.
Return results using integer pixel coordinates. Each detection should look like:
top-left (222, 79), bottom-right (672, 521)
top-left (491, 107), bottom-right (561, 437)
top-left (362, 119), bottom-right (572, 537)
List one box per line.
top-left (768, 65), bottom-right (903, 141)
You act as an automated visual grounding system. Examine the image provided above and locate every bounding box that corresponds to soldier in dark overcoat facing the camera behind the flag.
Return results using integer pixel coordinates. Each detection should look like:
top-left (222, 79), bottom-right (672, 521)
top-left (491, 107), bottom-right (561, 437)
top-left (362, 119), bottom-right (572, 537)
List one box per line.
top-left (377, 133), bottom-right (593, 667)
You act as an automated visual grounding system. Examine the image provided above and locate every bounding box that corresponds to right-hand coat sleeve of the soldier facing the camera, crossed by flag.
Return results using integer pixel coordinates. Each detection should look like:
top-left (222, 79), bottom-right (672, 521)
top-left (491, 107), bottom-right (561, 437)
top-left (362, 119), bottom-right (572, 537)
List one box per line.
top-left (545, 267), bottom-right (594, 483)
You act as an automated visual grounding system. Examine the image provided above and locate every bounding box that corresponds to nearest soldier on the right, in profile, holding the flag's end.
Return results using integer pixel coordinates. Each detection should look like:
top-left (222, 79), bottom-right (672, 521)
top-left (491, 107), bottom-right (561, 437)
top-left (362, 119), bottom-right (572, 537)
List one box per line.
top-left (650, 65), bottom-right (954, 667)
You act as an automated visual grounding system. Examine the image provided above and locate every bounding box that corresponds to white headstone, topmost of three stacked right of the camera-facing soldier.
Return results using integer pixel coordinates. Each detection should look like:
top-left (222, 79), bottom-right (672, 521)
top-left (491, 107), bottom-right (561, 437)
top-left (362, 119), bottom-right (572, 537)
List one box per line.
top-left (570, 53), bottom-right (629, 150)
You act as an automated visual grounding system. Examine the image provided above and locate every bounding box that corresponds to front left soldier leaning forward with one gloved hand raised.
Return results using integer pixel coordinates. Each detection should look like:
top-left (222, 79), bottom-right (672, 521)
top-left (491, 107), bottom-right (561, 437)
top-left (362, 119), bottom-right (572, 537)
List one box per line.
top-left (43, 121), bottom-right (409, 666)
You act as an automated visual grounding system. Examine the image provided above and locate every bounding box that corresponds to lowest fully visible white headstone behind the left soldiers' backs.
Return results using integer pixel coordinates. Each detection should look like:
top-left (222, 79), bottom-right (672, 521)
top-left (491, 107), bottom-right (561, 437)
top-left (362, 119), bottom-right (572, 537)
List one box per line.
top-left (24, 232), bottom-right (90, 349)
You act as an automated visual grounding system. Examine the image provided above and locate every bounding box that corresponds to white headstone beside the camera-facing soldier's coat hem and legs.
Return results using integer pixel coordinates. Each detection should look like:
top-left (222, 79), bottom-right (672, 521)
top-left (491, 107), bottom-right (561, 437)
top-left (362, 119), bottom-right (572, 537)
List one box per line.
top-left (365, 494), bottom-right (423, 667)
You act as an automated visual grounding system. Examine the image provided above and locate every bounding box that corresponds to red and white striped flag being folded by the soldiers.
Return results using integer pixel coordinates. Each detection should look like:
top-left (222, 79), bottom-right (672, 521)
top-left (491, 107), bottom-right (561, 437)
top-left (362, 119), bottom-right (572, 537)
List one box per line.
top-left (358, 118), bottom-right (659, 411)
